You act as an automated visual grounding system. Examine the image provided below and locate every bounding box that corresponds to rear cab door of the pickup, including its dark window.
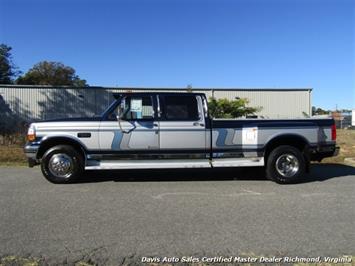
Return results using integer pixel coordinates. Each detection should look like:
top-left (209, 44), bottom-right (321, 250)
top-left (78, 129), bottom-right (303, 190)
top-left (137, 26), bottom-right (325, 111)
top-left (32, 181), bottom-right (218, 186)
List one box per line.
top-left (158, 94), bottom-right (207, 158)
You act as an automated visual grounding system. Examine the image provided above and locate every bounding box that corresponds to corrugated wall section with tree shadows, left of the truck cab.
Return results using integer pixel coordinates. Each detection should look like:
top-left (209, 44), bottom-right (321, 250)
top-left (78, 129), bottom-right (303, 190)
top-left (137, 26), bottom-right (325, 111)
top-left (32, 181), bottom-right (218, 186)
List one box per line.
top-left (0, 86), bottom-right (113, 120)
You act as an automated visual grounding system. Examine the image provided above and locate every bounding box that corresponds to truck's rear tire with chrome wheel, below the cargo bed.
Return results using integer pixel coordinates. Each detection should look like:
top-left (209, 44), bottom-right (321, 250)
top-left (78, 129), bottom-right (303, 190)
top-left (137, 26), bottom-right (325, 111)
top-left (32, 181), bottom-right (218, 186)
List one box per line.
top-left (266, 145), bottom-right (306, 184)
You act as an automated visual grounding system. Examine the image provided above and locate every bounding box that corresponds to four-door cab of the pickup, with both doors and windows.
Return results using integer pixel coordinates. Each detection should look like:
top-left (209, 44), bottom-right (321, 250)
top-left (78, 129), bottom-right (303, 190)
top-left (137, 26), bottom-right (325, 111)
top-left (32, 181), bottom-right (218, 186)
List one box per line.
top-left (99, 93), bottom-right (210, 158)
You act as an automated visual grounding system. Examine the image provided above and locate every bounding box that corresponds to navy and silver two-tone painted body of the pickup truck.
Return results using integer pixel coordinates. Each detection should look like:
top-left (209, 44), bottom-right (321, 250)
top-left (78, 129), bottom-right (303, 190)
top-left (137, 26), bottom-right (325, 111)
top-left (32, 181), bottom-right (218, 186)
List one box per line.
top-left (25, 93), bottom-right (337, 169)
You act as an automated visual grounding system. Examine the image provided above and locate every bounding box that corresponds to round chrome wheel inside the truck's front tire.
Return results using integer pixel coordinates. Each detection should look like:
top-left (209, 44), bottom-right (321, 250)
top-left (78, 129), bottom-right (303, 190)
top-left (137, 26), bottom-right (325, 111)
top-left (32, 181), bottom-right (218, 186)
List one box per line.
top-left (48, 153), bottom-right (74, 178)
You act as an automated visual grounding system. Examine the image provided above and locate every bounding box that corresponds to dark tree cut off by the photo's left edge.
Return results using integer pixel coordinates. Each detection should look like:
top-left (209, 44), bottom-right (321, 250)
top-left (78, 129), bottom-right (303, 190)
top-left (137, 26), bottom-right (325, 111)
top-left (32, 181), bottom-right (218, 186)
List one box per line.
top-left (0, 44), bottom-right (20, 84)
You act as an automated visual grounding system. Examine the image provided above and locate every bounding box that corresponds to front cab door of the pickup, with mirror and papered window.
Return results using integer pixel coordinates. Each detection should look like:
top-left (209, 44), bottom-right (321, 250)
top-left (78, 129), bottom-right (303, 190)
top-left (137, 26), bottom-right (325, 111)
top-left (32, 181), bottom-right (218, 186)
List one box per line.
top-left (99, 94), bottom-right (159, 154)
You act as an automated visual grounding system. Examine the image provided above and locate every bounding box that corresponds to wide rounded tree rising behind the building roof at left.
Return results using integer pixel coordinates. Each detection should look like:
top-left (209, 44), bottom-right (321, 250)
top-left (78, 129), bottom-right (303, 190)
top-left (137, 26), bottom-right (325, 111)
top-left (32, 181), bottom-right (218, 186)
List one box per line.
top-left (16, 61), bottom-right (88, 87)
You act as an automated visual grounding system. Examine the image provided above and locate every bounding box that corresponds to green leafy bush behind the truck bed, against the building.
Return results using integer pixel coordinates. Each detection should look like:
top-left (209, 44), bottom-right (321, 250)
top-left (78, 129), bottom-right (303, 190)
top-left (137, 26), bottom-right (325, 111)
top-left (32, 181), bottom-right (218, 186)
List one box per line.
top-left (208, 97), bottom-right (261, 118)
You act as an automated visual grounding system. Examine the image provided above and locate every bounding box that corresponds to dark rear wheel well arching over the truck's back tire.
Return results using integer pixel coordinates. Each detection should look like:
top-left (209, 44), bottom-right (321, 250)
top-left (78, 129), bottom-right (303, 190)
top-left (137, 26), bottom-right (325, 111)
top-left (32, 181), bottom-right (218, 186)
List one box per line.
top-left (264, 135), bottom-right (308, 160)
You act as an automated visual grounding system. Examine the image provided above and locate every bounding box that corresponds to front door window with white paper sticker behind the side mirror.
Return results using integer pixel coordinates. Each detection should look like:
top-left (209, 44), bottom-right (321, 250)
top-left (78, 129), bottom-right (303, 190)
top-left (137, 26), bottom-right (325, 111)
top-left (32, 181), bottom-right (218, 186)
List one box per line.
top-left (114, 96), bottom-right (154, 120)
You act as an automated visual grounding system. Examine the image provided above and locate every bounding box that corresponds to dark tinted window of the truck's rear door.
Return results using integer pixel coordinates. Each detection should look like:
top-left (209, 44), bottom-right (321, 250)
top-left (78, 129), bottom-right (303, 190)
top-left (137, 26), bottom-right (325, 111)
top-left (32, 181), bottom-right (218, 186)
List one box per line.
top-left (164, 96), bottom-right (199, 120)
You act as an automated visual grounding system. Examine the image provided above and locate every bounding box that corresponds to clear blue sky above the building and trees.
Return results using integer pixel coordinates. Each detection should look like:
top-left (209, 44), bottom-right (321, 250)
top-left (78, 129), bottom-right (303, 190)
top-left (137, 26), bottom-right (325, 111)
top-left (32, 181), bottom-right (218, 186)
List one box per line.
top-left (0, 0), bottom-right (355, 109)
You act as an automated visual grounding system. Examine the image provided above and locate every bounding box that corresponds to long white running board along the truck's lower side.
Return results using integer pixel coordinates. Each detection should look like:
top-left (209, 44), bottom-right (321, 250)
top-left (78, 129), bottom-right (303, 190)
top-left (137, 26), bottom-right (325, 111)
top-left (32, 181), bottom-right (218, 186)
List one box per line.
top-left (85, 157), bottom-right (264, 170)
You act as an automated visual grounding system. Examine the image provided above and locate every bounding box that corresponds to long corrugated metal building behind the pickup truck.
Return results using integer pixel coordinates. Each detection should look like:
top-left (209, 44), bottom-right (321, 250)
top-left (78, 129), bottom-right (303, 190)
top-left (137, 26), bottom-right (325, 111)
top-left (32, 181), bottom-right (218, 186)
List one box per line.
top-left (0, 85), bottom-right (312, 121)
